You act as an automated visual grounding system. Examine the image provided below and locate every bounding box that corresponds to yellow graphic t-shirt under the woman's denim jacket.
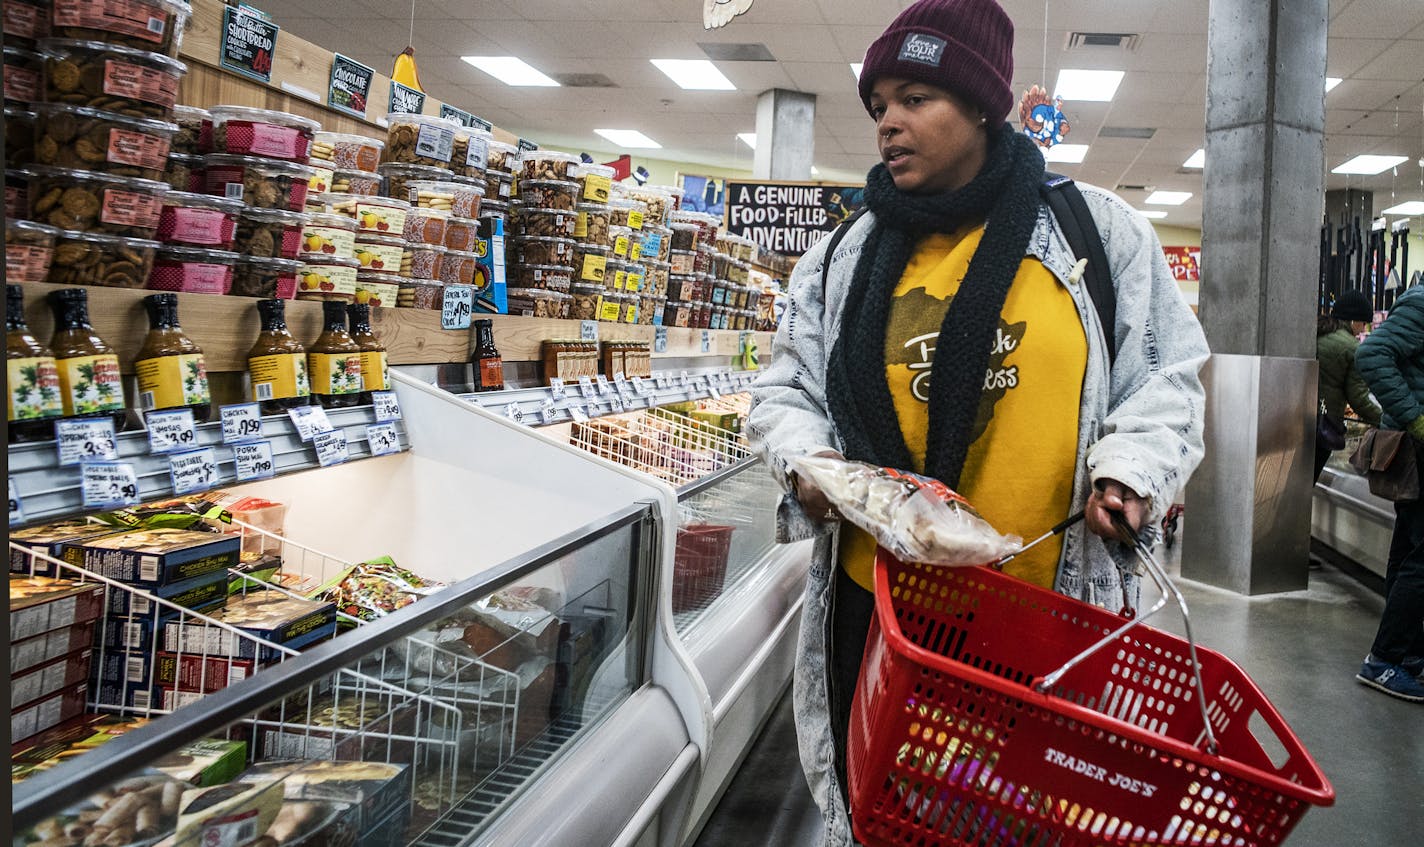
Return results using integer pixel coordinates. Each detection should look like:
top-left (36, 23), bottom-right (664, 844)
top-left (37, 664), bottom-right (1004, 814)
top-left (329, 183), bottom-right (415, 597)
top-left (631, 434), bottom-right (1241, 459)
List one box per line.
top-left (840, 226), bottom-right (1088, 591)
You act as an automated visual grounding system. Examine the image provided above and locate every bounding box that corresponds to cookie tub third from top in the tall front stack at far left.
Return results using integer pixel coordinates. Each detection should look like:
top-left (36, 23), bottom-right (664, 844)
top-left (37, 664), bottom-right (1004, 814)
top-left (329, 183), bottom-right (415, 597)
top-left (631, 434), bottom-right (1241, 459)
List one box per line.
top-left (33, 102), bottom-right (178, 179)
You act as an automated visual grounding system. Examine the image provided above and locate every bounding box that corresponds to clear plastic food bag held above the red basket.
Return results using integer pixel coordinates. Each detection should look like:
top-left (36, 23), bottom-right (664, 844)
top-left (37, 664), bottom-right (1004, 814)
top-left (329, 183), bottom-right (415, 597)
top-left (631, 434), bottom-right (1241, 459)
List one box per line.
top-left (790, 457), bottom-right (1024, 567)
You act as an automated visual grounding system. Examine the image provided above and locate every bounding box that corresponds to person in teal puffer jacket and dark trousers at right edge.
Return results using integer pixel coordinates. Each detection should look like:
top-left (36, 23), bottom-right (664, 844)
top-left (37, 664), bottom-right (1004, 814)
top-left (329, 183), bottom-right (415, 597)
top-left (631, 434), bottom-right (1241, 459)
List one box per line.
top-left (1356, 286), bottom-right (1424, 703)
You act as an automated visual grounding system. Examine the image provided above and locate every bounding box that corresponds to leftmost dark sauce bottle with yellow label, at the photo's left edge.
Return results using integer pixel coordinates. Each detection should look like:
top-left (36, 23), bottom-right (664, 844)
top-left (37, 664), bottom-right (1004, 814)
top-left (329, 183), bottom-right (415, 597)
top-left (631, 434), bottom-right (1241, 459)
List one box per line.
top-left (4, 285), bottom-right (64, 444)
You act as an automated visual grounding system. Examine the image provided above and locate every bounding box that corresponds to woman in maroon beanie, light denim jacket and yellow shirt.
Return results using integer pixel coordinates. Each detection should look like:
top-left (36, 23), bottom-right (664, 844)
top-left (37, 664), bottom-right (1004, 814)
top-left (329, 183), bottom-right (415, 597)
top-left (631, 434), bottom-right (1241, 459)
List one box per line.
top-left (749, 0), bottom-right (1208, 846)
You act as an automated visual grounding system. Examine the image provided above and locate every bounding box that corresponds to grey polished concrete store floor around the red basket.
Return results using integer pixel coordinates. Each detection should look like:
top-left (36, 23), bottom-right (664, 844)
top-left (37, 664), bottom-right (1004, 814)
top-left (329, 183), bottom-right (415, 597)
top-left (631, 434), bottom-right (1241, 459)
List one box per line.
top-left (695, 540), bottom-right (1424, 847)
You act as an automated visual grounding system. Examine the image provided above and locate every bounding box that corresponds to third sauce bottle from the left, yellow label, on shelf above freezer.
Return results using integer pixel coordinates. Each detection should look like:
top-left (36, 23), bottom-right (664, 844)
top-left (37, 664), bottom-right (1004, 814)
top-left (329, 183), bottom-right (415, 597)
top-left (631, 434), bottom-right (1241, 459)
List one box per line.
top-left (134, 293), bottom-right (212, 421)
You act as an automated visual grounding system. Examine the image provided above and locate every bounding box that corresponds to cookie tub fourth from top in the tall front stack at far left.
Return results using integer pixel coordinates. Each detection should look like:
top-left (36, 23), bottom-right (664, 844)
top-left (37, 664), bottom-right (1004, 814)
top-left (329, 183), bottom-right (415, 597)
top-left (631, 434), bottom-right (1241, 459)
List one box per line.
top-left (27, 167), bottom-right (168, 236)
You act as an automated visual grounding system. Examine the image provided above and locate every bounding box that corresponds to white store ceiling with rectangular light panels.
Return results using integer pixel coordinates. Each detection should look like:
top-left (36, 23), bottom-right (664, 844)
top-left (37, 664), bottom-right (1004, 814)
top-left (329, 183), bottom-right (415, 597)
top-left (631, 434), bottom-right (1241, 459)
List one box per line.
top-left (255, 0), bottom-right (1424, 226)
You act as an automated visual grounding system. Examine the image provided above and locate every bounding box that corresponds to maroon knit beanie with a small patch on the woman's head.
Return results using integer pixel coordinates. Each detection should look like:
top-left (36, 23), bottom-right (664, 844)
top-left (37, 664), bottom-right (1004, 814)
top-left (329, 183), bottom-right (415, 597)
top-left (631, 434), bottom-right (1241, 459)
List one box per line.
top-left (860, 0), bottom-right (1014, 125)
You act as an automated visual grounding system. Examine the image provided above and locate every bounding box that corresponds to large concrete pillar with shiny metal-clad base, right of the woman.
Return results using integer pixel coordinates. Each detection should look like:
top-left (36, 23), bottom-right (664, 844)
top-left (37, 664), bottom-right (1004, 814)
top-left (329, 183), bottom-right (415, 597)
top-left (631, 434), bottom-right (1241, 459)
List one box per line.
top-left (1182, 0), bottom-right (1329, 594)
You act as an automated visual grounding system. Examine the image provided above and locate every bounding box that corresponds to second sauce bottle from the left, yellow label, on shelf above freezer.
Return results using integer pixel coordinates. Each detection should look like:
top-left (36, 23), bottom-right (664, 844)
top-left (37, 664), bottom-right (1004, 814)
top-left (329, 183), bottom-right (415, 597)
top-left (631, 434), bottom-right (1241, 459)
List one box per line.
top-left (50, 288), bottom-right (125, 430)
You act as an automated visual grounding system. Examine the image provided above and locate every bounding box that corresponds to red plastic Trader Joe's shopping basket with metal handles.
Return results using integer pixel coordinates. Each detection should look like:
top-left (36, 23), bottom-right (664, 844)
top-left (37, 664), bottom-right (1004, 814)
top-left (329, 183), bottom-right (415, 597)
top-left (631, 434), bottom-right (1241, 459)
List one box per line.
top-left (847, 551), bottom-right (1334, 847)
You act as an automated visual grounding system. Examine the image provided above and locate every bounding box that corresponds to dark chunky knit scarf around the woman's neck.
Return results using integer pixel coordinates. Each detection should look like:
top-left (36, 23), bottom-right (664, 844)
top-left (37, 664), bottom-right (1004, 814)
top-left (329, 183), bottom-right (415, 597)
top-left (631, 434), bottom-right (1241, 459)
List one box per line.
top-left (826, 124), bottom-right (1044, 488)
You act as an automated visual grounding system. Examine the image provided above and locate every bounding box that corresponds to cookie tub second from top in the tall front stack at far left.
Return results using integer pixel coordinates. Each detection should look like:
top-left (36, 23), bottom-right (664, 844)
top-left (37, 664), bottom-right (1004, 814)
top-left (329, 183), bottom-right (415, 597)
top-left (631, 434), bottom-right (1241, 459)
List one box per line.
top-left (37, 38), bottom-right (185, 116)
